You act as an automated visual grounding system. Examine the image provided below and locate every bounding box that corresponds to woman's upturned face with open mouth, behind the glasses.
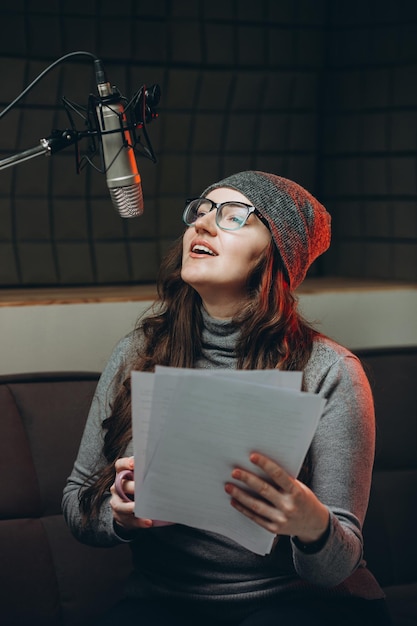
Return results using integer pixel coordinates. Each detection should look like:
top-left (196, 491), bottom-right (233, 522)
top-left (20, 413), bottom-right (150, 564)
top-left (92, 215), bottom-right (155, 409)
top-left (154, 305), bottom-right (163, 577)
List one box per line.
top-left (181, 187), bottom-right (271, 318)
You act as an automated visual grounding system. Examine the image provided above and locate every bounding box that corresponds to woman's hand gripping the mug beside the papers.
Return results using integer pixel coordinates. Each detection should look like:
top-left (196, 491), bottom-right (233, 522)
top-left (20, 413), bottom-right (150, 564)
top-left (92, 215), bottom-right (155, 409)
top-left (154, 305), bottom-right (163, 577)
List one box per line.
top-left (110, 457), bottom-right (153, 531)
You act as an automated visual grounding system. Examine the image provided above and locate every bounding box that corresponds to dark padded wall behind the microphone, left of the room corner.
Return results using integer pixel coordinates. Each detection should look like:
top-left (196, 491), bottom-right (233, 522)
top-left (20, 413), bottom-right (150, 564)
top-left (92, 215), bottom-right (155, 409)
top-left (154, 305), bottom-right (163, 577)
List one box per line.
top-left (0, 0), bottom-right (324, 285)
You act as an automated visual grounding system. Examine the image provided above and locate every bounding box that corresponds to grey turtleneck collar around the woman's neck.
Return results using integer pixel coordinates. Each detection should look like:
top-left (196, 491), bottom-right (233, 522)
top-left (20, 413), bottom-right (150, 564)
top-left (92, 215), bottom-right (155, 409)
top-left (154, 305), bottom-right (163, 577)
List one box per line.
top-left (196, 307), bottom-right (240, 369)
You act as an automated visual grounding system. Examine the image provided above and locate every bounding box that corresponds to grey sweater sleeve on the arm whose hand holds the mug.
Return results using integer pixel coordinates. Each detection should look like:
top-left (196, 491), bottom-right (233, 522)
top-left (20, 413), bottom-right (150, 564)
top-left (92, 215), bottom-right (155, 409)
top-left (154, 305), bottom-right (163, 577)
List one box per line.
top-left (62, 335), bottom-right (132, 546)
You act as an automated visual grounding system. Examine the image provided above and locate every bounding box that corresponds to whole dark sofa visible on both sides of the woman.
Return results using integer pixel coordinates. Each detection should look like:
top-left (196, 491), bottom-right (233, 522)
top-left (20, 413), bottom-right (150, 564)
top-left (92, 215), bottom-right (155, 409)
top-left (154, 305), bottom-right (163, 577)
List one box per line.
top-left (0, 348), bottom-right (417, 626)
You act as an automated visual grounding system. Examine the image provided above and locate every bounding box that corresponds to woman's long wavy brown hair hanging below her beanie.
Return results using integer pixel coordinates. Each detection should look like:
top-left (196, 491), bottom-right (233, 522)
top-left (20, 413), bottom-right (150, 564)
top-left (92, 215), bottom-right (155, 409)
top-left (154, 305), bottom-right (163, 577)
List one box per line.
top-left (80, 238), bottom-right (318, 521)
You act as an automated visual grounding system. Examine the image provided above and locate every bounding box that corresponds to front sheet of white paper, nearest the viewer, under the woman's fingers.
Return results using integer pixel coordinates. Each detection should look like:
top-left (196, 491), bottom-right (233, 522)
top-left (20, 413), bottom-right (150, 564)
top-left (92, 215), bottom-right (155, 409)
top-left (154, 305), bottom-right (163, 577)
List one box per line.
top-left (135, 372), bottom-right (325, 554)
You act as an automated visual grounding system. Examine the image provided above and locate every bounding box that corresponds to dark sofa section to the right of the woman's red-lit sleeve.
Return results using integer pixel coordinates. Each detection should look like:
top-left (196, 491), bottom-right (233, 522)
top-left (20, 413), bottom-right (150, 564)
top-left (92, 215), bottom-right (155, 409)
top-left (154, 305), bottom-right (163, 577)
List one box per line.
top-left (358, 347), bottom-right (417, 626)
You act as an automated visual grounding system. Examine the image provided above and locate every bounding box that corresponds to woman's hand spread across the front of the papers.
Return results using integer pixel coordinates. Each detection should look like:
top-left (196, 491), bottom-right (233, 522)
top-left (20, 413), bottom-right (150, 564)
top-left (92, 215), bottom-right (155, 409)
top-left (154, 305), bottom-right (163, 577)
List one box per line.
top-left (225, 453), bottom-right (329, 543)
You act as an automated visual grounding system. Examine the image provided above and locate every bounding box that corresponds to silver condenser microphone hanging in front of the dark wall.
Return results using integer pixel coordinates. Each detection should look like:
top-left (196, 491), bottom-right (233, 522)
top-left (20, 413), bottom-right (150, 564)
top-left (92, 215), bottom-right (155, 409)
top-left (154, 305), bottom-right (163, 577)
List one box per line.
top-left (94, 59), bottom-right (143, 217)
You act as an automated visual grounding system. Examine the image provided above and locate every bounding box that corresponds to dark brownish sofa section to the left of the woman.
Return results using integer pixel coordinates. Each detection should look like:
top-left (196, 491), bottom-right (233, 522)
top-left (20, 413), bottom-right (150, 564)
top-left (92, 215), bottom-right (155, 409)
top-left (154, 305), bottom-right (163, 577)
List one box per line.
top-left (0, 373), bottom-right (131, 626)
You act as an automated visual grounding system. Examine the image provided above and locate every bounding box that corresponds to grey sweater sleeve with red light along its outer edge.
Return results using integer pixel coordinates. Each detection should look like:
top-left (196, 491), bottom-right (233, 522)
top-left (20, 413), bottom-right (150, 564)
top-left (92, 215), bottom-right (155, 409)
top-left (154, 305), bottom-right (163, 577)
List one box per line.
top-left (292, 343), bottom-right (375, 587)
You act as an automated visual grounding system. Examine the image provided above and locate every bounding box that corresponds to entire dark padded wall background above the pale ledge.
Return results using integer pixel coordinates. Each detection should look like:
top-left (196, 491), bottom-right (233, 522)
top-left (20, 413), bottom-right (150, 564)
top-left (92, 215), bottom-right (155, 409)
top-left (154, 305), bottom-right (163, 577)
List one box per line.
top-left (0, 0), bottom-right (417, 287)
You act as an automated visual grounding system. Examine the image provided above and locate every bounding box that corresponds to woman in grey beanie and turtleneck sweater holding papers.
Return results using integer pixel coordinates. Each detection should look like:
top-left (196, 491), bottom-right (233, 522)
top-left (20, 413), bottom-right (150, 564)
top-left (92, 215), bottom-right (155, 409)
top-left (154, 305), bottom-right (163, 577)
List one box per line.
top-left (63, 171), bottom-right (390, 626)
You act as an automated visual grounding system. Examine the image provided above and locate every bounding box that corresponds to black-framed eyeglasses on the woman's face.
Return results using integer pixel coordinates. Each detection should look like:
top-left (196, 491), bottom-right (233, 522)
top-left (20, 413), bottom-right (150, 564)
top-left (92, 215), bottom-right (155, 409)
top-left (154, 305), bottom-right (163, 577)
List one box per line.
top-left (182, 198), bottom-right (269, 230)
